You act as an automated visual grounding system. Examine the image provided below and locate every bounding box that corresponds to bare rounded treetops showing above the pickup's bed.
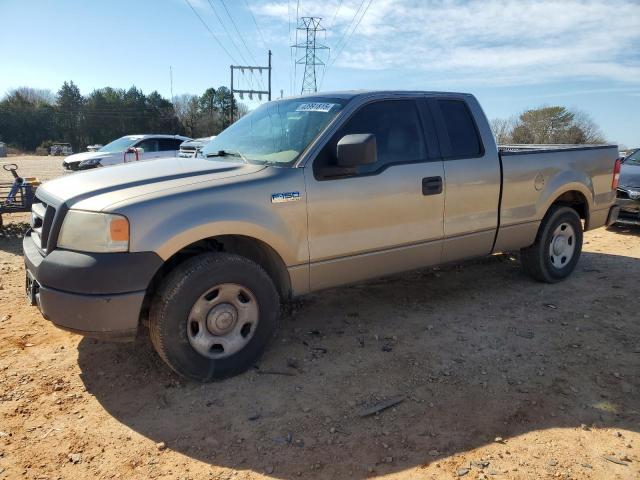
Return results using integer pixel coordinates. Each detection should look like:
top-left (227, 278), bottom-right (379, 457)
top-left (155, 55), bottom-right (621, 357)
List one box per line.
top-left (491, 106), bottom-right (606, 145)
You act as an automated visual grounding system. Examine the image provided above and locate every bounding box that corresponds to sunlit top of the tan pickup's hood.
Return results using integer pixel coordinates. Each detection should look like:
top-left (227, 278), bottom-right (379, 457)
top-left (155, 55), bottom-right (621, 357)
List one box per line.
top-left (36, 157), bottom-right (265, 211)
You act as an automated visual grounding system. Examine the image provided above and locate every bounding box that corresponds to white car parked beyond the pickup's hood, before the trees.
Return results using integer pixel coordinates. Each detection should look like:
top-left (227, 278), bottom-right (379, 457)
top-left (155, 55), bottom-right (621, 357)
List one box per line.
top-left (62, 135), bottom-right (190, 170)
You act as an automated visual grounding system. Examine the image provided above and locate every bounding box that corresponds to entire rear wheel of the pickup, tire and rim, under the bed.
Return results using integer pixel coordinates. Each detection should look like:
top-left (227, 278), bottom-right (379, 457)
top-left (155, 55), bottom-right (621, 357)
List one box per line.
top-left (520, 206), bottom-right (582, 283)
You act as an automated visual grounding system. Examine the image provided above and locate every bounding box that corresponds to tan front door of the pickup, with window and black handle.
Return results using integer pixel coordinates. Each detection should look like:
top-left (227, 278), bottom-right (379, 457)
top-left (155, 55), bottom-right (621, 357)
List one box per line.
top-left (305, 97), bottom-right (444, 290)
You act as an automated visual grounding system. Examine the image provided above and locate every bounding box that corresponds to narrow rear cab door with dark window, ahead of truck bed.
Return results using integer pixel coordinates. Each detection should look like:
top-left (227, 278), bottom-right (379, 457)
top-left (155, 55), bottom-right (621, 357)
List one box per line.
top-left (428, 97), bottom-right (501, 262)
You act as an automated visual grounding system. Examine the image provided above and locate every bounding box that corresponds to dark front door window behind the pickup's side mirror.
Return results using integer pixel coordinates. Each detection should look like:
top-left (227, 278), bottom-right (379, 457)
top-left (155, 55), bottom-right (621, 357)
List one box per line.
top-left (313, 100), bottom-right (427, 178)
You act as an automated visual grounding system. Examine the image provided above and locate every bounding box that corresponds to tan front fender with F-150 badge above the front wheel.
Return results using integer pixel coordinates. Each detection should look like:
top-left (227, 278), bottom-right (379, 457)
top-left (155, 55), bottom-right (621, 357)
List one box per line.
top-left (120, 169), bottom-right (309, 267)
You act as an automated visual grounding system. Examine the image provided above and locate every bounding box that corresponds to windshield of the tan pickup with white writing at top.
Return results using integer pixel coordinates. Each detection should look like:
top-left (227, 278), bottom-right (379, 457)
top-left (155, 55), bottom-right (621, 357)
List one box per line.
top-left (203, 97), bottom-right (347, 166)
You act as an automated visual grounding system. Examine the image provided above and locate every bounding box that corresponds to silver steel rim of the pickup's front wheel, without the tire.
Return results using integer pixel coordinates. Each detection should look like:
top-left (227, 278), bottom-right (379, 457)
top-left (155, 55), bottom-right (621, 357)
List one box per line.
top-left (187, 283), bottom-right (259, 359)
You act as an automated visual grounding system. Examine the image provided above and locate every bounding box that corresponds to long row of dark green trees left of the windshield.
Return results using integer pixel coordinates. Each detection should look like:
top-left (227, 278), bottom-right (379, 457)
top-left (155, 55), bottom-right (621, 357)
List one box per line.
top-left (0, 82), bottom-right (247, 153)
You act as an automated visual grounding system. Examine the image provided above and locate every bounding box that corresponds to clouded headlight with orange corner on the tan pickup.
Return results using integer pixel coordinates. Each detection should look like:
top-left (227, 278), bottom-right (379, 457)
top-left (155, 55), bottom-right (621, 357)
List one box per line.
top-left (58, 210), bottom-right (129, 253)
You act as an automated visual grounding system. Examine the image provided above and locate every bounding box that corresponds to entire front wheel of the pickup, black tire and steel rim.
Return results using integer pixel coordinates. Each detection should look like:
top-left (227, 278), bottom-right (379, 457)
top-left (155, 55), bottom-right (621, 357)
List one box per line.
top-left (149, 253), bottom-right (280, 382)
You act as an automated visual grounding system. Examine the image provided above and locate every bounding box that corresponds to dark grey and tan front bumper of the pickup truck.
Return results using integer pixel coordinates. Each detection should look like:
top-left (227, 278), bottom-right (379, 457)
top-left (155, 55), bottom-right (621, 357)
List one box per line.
top-left (22, 235), bottom-right (162, 340)
